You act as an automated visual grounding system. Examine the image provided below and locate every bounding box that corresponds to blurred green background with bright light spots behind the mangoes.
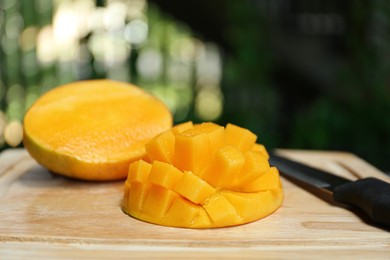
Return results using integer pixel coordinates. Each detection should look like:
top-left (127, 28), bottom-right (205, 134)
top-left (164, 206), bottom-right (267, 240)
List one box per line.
top-left (0, 0), bottom-right (390, 172)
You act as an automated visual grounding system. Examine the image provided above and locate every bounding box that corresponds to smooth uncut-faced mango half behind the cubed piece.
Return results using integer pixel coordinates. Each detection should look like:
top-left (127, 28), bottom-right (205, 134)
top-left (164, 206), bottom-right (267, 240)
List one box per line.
top-left (23, 80), bottom-right (172, 180)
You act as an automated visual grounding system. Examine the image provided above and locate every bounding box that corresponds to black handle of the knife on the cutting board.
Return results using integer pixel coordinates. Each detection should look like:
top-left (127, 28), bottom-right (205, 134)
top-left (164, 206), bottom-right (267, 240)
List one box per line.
top-left (333, 178), bottom-right (390, 226)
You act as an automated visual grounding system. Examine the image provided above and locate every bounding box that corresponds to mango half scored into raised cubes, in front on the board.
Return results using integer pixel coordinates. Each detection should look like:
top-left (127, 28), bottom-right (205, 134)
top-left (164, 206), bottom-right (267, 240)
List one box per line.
top-left (122, 122), bottom-right (283, 228)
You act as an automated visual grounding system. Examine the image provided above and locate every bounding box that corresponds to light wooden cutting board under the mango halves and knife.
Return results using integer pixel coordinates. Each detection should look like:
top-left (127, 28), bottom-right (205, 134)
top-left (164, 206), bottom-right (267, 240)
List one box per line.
top-left (0, 149), bottom-right (390, 259)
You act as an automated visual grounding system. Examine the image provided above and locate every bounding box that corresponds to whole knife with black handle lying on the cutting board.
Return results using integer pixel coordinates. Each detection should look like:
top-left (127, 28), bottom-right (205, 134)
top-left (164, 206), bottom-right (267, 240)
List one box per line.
top-left (269, 153), bottom-right (390, 227)
